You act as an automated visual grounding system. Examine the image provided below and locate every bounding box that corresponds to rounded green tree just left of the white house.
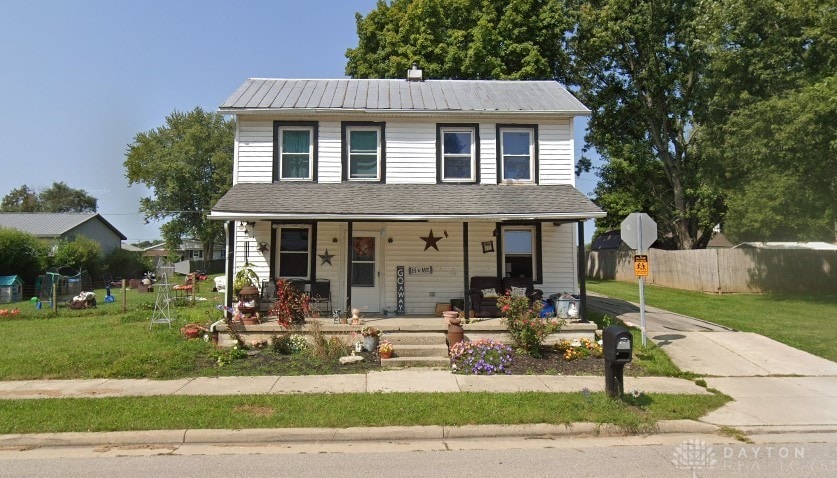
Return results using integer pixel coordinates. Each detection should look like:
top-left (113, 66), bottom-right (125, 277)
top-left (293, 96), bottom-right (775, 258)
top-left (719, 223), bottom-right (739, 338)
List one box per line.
top-left (124, 107), bottom-right (235, 257)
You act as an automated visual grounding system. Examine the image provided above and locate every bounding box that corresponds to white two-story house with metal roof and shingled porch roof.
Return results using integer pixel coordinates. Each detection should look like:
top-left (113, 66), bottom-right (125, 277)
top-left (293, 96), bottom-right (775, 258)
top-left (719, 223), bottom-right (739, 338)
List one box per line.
top-left (210, 70), bottom-right (605, 316)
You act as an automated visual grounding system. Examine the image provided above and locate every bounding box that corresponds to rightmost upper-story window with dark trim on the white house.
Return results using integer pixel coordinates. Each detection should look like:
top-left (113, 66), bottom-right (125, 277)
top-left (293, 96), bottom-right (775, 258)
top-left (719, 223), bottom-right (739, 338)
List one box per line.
top-left (497, 125), bottom-right (538, 182)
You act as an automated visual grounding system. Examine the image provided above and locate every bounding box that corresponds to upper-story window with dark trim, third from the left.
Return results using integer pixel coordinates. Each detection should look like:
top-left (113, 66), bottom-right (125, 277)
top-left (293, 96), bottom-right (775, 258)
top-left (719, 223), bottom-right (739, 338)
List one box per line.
top-left (436, 124), bottom-right (479, 182)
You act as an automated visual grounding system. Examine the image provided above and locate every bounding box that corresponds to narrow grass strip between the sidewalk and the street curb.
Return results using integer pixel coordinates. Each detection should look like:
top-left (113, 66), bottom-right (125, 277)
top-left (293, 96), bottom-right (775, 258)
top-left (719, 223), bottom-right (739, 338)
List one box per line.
top-left (0, 392), bottom-right (729, 434)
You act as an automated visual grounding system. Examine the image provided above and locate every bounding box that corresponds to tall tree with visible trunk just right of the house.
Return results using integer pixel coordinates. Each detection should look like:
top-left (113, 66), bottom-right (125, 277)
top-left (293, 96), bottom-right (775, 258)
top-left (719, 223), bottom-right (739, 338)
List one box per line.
top-left (567, 0), bottom-right (723, 249)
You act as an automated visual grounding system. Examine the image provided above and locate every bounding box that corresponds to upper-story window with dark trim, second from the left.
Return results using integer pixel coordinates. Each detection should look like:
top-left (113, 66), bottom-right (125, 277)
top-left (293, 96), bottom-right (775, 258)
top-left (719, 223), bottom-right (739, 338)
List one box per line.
top-left (342, 122), bottom-right (386, 181)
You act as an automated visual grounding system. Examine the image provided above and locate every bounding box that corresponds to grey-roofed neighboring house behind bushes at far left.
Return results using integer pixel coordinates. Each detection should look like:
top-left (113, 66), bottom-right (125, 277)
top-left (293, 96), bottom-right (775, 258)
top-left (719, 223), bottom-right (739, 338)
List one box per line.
top-left (0, 212), bottom-right (126, 254)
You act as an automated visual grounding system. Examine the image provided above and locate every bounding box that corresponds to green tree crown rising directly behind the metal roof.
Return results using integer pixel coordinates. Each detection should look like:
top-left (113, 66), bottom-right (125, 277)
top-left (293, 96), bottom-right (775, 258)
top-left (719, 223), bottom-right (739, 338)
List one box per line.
top-left (346, 0), bottom-right (570, 80)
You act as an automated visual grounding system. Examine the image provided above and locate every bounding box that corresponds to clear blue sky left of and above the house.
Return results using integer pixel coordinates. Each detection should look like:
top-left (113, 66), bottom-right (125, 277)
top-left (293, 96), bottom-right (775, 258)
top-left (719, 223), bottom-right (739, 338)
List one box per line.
top-left (0, 0), bottom-right (595, 242)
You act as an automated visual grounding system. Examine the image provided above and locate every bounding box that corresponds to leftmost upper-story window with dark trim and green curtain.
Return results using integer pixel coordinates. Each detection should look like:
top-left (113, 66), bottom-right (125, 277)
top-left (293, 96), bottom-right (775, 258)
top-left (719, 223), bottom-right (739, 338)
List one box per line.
top-left (273, 121), bottom-right (317, 181)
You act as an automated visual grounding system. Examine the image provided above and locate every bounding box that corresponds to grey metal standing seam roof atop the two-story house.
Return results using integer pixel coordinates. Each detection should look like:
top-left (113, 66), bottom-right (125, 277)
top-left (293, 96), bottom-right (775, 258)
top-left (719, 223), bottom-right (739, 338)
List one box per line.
top-left (220, 78), bottom-right (590, 116)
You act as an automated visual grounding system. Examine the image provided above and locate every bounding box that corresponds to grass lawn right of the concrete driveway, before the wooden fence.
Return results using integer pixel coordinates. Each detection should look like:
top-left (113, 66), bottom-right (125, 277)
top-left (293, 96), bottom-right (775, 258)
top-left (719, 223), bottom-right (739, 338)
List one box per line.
top-left (587, 280), bottom-right (837, 361)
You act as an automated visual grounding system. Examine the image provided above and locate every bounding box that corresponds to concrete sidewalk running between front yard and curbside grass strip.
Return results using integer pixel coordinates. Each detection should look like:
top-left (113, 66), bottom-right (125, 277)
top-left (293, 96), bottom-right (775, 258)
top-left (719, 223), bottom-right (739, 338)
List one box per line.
top-left (0, 368), bottom-right (709, 399)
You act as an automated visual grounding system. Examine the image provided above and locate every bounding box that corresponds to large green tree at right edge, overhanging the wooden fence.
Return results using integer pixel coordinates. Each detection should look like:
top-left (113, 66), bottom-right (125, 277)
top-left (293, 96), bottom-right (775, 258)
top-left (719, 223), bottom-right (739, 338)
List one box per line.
top-left (698, 0), bottom-right (837, 241)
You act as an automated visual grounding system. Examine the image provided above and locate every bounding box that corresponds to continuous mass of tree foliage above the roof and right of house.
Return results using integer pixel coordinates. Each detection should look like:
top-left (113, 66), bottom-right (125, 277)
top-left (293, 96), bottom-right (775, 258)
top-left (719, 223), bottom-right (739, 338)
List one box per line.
top-left (346, 0), bottom-right (837, 248)
